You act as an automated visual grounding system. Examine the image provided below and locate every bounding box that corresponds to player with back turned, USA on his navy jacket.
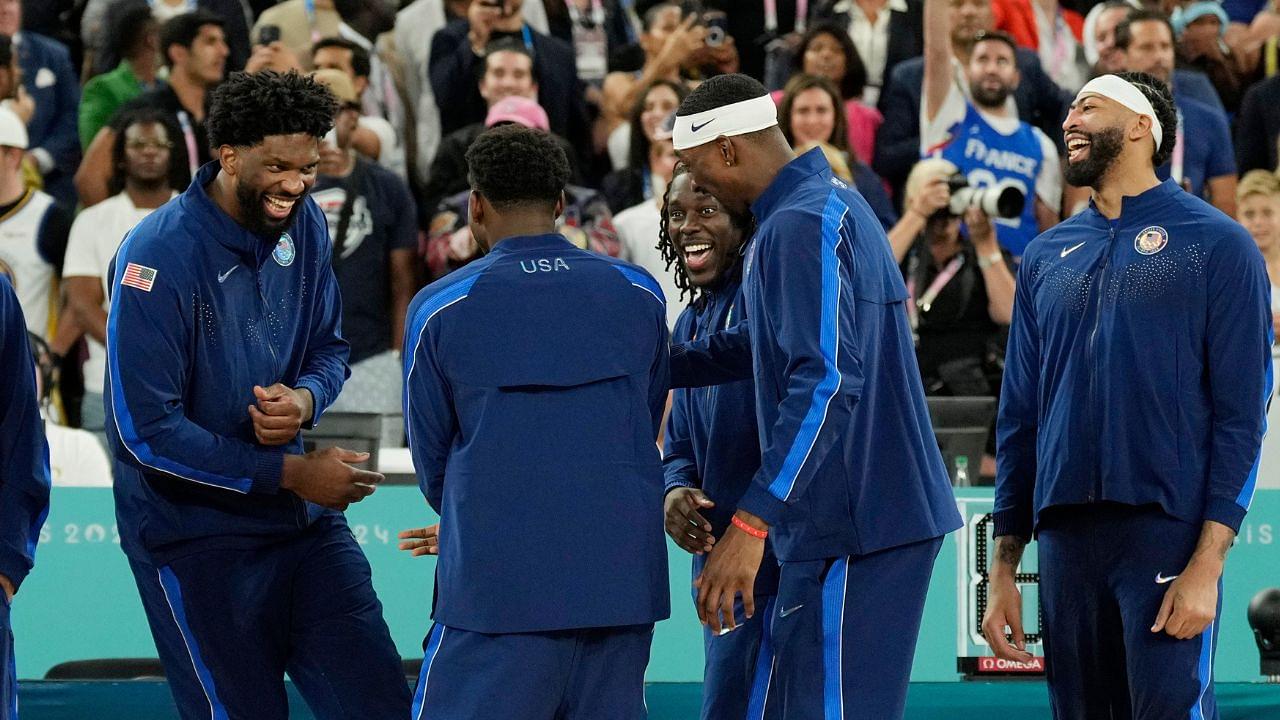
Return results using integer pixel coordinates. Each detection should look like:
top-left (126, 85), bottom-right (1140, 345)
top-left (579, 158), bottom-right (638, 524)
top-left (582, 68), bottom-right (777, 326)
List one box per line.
top-left (403, 126), bottom-right (669, 720)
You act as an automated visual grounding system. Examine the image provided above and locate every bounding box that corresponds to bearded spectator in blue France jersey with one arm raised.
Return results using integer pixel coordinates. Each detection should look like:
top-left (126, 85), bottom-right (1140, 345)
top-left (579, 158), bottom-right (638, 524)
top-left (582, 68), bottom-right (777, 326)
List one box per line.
top-left (920, 0), bottom-right (1062, 258)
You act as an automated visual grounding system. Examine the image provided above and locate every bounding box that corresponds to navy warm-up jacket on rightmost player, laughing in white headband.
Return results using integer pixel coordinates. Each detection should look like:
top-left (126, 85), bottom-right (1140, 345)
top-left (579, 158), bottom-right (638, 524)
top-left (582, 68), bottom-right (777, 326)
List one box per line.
top-left (995, 181), bottom-right (1272, 538)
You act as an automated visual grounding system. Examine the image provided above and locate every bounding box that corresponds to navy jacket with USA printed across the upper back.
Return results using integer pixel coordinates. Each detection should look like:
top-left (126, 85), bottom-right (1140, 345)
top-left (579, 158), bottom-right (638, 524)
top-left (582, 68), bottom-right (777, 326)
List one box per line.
top-left (403, 234), bottom-right (671, 633)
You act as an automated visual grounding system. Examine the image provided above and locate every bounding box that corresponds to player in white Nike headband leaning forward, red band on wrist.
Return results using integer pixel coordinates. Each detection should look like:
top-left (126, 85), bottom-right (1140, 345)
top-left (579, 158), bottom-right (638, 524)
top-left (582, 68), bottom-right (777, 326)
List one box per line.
top-left (672, 74), bottom-right (960, 719)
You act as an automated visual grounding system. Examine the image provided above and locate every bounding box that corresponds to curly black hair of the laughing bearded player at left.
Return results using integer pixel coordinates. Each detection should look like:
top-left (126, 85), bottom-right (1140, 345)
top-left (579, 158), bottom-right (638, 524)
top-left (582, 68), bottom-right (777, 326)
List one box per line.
top-left (205, 70), bottom-right (338, 149)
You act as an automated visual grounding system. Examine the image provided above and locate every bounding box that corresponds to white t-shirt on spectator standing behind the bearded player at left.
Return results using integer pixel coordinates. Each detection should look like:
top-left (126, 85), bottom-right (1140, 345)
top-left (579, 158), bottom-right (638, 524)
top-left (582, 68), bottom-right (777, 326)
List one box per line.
top-left (63, 192), bottom-right (178, 395)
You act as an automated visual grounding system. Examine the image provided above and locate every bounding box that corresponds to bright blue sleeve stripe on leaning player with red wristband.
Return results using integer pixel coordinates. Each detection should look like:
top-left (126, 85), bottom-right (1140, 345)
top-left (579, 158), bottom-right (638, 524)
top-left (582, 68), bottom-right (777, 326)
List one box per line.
top-left (769, 191), bottom-right (849, 502)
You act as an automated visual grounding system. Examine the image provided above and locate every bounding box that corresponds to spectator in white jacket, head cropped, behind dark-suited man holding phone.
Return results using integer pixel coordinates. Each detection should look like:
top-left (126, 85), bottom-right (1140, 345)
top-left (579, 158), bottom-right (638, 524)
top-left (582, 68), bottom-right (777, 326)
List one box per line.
top-left (394, 0), bottom-right (547, 187)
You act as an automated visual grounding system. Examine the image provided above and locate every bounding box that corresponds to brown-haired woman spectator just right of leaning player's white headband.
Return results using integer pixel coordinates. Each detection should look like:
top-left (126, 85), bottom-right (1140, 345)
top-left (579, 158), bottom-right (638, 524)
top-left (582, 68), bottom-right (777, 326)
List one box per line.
top-left (778, 74), bottom-right (897, 232)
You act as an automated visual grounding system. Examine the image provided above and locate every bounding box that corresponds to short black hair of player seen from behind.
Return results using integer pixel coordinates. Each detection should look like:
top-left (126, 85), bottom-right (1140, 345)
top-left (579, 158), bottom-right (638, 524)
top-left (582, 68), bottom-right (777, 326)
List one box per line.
top-left (467, 123), bottom-right (570, 209)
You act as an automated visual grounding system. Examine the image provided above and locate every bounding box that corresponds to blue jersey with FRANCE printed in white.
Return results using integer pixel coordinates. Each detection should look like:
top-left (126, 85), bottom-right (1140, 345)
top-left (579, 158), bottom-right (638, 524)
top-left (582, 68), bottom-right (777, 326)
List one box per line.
top-left (934, 102), bottom-right (1044, 258)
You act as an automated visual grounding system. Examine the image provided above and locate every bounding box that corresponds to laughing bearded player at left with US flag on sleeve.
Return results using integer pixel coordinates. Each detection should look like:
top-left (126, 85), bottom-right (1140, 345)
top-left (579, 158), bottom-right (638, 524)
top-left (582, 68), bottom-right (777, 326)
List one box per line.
top-left (104, 72), bottom-right (410, 720)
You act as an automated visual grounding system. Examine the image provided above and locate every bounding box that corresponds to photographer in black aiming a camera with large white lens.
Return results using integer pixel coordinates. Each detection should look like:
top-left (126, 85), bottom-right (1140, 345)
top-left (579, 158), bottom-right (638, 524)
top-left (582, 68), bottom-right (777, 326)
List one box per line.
top-left (895, 159), bottom-right (1014, 396)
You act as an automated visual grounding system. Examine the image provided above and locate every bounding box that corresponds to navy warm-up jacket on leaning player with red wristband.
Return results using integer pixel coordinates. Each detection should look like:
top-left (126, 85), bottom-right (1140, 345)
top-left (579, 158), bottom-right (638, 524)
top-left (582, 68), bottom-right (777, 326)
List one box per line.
top-left (672, 150), bottom-right (960, 562)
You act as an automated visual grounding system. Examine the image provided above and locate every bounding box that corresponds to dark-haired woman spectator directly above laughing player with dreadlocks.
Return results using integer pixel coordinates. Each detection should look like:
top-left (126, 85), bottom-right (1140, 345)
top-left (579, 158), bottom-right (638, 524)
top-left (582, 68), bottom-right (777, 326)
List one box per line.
top-left (600, 79), bottom-right (687, 212)
